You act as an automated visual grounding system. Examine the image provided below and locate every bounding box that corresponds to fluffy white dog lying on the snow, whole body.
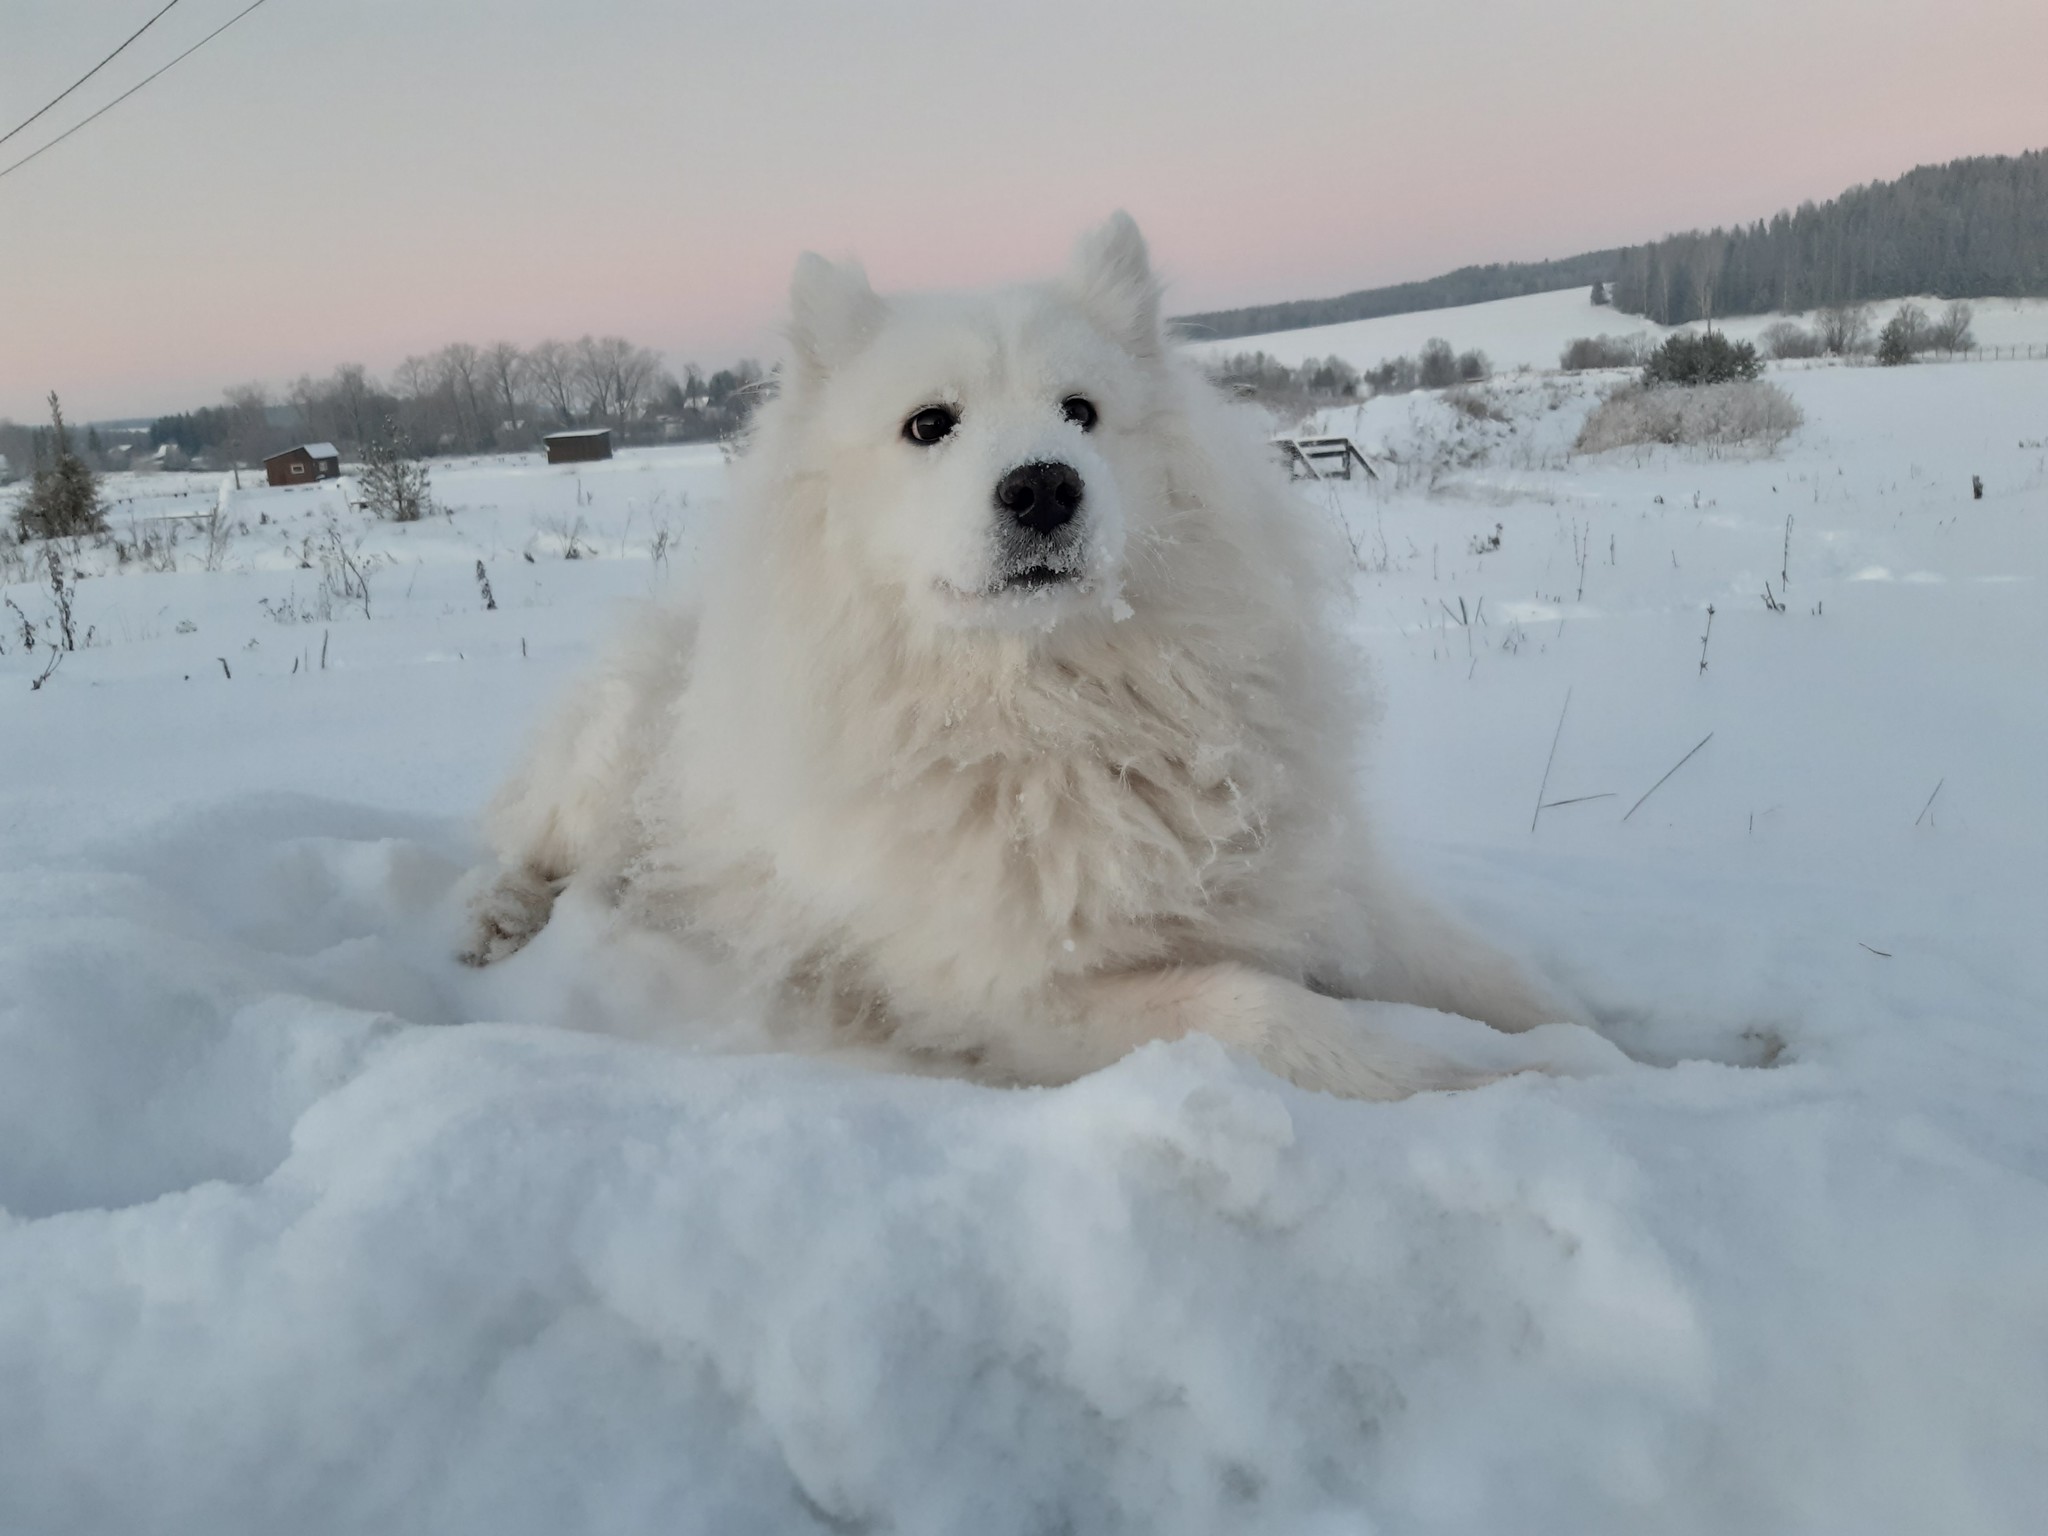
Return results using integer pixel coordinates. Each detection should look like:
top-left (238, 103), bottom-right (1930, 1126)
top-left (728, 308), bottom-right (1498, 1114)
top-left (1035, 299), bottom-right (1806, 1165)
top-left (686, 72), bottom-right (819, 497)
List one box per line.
top-left (467, 215), bottom-right (1565, 1098)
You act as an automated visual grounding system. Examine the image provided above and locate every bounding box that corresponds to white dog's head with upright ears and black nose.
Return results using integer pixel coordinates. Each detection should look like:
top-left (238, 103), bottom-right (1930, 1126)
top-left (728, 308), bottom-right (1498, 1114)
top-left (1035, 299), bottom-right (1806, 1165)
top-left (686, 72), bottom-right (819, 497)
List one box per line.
top-left (791, 213), bottom-right (1165, 629)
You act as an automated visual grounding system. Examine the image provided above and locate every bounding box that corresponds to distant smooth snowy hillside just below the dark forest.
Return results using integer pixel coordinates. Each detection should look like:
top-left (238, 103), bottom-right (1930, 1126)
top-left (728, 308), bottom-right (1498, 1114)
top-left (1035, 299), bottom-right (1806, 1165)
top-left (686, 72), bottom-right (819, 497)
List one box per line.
top-left (1192, 287), bottom-right (2048, 373)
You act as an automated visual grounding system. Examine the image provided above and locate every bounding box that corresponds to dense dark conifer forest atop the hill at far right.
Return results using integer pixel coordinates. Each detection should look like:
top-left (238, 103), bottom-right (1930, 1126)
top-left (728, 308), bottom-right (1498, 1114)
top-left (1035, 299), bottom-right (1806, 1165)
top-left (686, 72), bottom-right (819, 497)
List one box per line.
top-left (1612, 150), bottom-right (2048, 326)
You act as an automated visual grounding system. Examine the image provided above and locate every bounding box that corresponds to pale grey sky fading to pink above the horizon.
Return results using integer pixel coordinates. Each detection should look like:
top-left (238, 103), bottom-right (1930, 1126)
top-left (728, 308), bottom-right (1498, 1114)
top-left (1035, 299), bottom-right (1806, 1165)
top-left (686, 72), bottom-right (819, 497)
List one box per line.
top-left (0, 0), bottom-right (2048, 420)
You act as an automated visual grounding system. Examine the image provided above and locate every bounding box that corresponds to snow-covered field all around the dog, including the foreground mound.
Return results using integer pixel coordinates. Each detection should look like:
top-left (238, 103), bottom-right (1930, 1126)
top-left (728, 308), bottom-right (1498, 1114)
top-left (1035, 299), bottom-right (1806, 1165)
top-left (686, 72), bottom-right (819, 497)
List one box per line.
top-left (0, 358), bottom-right (2048, 1536)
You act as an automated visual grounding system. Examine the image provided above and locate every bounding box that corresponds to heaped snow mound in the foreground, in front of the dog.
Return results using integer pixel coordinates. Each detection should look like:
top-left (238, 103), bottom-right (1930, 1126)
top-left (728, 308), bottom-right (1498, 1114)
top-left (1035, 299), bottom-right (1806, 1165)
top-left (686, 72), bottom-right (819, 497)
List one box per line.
top-left (0, 801), bottom-right (2048, 1532)
